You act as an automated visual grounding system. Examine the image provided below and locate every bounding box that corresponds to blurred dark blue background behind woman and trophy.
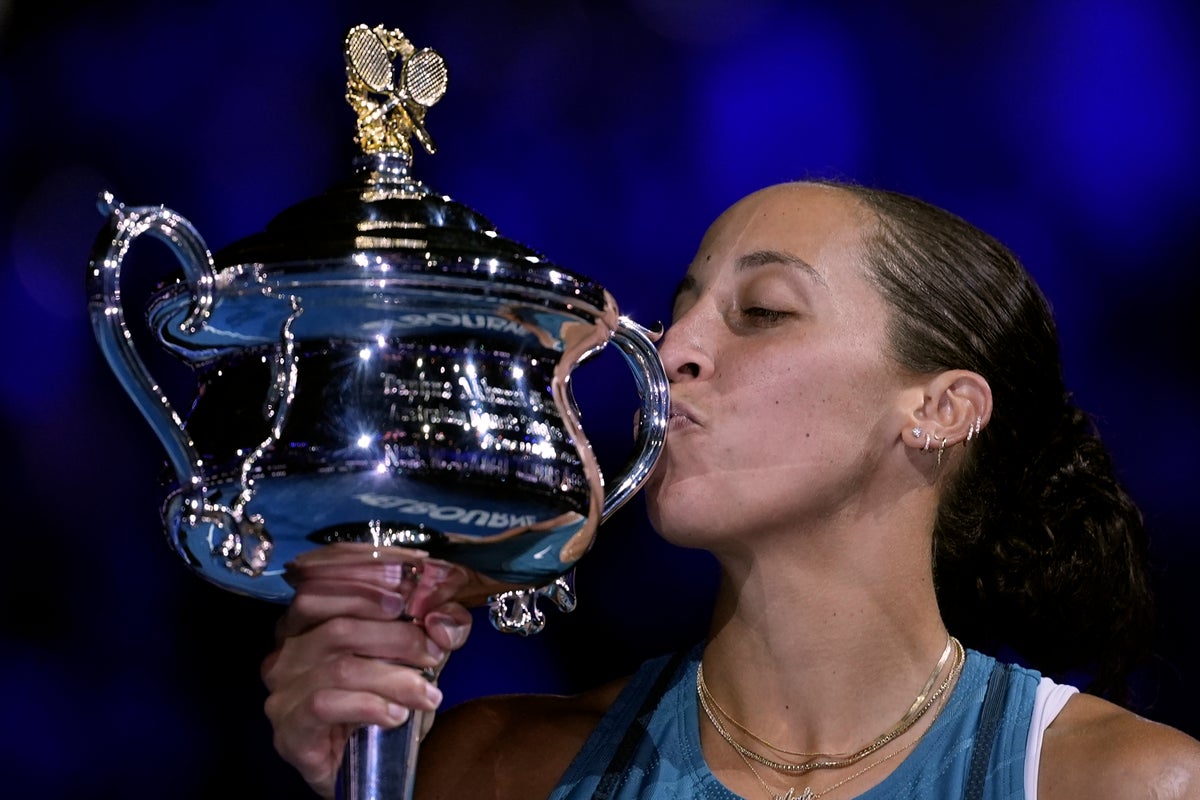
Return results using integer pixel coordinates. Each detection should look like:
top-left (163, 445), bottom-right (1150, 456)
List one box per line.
top-left (0, 0), bottom-right (1200, 800)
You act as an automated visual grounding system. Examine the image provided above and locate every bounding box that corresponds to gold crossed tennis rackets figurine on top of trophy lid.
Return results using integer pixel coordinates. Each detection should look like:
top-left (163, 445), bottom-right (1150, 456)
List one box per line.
top-left (344, 25), bottom-right (448, 155)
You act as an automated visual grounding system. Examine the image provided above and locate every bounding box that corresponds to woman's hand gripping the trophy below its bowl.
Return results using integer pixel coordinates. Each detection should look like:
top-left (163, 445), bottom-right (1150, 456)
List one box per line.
top-left (262, 545), bottom-right (470, 798)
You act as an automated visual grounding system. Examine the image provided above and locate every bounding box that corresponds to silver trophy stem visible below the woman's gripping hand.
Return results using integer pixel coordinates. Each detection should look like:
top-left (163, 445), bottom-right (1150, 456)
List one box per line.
top-left (336, 711), bottom-right (421, 800)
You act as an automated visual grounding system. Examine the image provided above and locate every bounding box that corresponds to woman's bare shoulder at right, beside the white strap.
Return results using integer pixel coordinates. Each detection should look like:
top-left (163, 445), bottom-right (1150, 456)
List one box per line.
top-left (1038, 694), bottom-right (1200, 800)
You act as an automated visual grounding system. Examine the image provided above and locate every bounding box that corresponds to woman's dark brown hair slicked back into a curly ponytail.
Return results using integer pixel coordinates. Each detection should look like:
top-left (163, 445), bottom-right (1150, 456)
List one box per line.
top-left (822, 181), bottom-right (1153, 703)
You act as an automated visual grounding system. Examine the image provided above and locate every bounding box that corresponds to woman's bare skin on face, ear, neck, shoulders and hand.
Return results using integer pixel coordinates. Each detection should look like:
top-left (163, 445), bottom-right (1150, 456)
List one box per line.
top-left (264, 185), bottom-right (1200, 800)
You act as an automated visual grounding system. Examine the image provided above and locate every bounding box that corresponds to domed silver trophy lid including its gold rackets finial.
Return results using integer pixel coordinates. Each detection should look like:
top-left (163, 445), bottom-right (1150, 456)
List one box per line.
top-left (194, 25), bottom-right (611, 328)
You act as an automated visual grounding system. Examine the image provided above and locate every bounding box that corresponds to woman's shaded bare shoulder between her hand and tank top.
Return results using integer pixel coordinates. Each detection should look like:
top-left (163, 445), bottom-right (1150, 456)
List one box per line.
top-left (416, 679), bottom-right (628, 800)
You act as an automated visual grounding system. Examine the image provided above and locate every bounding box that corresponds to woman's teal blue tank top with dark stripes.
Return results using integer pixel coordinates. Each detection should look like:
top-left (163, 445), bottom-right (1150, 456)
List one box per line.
top-left (550, 646), bottom-right (1040, 800)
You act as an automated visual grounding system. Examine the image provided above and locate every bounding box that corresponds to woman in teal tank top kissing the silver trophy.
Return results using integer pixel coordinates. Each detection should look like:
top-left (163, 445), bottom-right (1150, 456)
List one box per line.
top-left (263, 184), bottom-right (1200, 800)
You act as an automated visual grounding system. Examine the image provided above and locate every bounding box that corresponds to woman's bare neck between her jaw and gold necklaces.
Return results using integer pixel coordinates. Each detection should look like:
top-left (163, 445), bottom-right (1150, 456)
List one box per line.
top-left (704, 513), bottom-right (947, 753)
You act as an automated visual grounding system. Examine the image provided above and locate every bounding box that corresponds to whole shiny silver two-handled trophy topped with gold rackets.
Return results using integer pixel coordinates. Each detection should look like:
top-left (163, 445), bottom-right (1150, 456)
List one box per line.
top-left (88, 25), bottom-right (667, 800)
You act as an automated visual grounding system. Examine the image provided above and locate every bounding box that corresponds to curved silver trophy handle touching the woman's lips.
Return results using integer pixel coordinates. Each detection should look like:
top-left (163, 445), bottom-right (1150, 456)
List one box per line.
top-left (600, 317), bottom-right (671, 522)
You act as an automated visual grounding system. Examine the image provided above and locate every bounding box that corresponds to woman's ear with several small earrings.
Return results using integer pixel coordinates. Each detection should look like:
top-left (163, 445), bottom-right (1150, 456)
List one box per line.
top-left (902, 369), bottom-right (991, 450)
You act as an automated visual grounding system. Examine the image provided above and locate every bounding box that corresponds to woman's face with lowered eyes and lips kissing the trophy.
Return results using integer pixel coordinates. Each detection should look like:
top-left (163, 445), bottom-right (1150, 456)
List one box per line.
top-left (647, 185), bottom-right (914, 549)
